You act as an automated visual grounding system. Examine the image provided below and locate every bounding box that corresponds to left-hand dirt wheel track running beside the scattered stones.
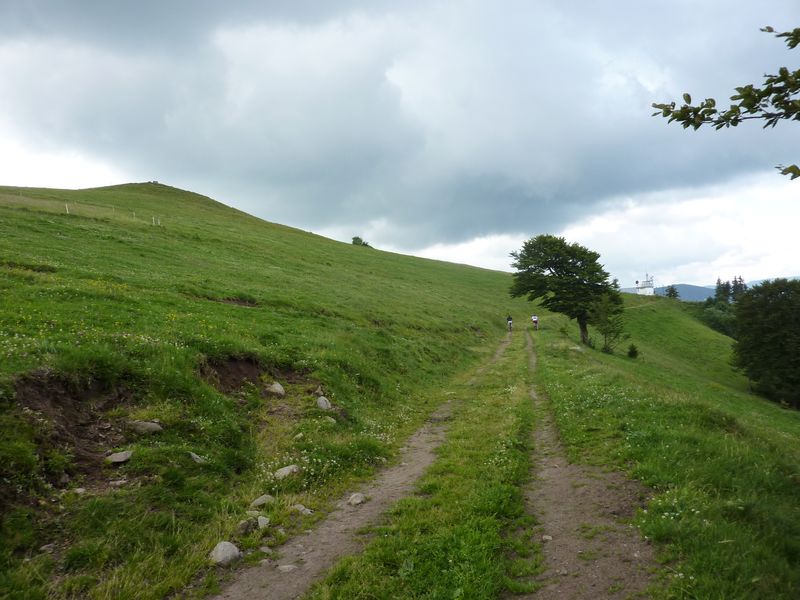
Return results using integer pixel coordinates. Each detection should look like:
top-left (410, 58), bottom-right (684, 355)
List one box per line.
top-left (209, 336), bottom-right (511, 600)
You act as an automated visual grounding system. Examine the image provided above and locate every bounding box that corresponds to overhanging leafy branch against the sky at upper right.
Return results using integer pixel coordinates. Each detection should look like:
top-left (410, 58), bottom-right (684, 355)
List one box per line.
top-left (652, 27), bottom-right (800, 179)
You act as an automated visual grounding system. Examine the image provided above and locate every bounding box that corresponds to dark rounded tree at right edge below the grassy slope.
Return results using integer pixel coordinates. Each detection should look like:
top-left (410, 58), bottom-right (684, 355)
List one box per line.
top-left (734, 279), bottom-right (800, 408)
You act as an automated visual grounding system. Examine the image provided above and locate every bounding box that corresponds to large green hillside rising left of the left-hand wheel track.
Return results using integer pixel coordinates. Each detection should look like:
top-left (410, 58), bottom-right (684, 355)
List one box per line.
top-left (0, 184), bottom-right (526, 598)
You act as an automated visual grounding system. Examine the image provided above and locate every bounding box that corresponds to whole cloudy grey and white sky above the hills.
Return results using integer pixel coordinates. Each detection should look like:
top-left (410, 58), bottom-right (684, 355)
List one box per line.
top-left (0, 0), bottom-right (800, 287)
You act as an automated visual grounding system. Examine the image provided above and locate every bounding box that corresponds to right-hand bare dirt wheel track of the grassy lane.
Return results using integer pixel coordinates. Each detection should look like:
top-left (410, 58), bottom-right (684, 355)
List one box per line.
top-left (516, 333), bottom-right (656, 600)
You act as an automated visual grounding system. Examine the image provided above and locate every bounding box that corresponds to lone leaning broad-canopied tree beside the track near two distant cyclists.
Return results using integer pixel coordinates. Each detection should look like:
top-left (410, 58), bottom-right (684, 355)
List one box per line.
top-left (511, 234), bottom-right (622, 344)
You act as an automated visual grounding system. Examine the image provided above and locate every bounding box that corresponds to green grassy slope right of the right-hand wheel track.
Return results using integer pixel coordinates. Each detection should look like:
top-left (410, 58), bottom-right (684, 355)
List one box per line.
top-left (537, 295), bottom-right (800, 599)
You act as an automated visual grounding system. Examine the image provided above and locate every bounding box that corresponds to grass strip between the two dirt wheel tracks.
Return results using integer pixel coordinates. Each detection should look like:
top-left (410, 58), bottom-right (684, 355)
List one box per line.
top-left (310, 334), bottom-right (540, 599)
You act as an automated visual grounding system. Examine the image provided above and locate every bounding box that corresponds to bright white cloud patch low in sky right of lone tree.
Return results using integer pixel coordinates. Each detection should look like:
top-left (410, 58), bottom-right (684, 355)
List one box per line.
top-left (563, 174), bottom-right (800, 287)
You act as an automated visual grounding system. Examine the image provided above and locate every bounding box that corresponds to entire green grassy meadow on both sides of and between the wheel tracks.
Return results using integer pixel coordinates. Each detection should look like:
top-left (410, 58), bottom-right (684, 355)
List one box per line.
top-left (0, 183), bottom-right (800, 599)
